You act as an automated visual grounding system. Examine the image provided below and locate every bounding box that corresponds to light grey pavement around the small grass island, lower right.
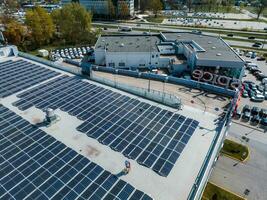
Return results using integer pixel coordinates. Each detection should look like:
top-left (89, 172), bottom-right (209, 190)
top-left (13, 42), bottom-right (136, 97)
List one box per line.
top-left (210, 123), bottom-right (267, 200)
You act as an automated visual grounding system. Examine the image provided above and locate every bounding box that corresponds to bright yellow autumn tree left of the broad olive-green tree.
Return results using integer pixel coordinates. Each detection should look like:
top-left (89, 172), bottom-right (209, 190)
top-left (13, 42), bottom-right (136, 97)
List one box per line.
top-left (25, 7), bottom-right (55, 47)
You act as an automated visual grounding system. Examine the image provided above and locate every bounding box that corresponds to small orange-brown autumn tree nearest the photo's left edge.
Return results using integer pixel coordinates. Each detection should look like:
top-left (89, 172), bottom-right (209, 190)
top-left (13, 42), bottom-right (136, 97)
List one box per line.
top-left (3, 20), bottom-right (26, 46)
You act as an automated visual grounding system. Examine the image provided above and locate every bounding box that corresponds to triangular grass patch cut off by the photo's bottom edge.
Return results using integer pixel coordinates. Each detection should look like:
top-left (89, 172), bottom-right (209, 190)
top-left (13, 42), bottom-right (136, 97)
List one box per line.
top-left (202, 182), bottom-right (245, 200)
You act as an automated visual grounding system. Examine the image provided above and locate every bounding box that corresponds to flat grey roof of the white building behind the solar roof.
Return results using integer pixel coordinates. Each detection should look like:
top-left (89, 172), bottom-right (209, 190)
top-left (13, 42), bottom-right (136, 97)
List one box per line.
top-left (95, 32), bottom-right (244, 65)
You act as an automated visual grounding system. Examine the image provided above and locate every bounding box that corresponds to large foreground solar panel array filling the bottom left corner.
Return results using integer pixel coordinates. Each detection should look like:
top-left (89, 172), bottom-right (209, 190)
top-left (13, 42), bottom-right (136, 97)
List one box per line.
top-left (0, 105), bottom-right (152, 200)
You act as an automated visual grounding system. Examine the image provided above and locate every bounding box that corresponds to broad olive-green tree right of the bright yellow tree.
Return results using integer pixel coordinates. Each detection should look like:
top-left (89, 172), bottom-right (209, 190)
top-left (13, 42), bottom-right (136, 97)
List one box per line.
top-left (52, 3), bottom-right (92, 44)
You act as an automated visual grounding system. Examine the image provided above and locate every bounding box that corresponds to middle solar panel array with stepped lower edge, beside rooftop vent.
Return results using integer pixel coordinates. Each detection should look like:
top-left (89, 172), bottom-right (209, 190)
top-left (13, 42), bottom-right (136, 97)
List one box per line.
top-left (13, 76), bottom-right (199, 176)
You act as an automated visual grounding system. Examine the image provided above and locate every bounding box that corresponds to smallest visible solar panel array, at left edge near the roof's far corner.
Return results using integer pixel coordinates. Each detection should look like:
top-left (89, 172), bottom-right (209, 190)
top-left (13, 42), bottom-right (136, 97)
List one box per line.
top-left (0, 60), bottom-right (60, 97)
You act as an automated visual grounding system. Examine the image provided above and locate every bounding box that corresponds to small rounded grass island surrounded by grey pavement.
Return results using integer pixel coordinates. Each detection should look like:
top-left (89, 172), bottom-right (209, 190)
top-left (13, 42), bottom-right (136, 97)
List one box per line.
top-left (221, 139), bottom-right (249, 161)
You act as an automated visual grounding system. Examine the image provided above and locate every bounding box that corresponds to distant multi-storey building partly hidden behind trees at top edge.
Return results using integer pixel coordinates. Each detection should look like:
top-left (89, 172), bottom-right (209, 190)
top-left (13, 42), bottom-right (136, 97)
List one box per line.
top-left (61, 0), bottom-right (134, 16)
